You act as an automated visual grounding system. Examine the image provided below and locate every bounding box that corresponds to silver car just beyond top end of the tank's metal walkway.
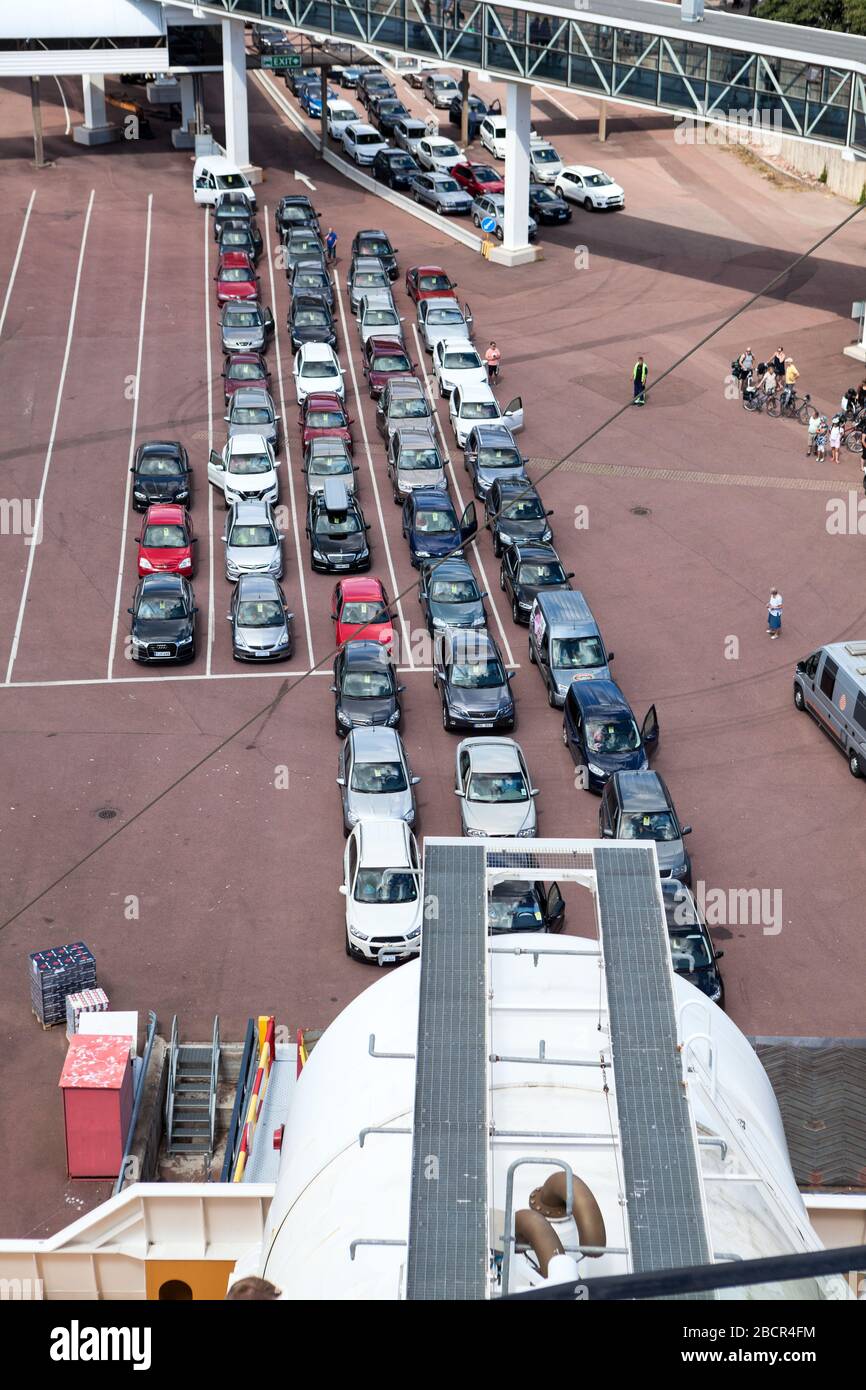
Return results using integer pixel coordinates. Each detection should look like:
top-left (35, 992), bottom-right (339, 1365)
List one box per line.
top-left (455, 738), bottom-right (538, 840)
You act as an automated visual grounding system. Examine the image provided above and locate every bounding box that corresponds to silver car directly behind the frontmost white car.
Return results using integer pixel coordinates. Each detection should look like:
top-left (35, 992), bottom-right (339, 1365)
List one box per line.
top-left (336, 724), bottom-right (421, 834)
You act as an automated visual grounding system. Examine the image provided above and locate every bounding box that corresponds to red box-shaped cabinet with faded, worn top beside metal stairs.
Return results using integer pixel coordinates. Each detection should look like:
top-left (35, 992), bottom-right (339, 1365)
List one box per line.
top-left (60, 1033), bottom-right (132, 1177)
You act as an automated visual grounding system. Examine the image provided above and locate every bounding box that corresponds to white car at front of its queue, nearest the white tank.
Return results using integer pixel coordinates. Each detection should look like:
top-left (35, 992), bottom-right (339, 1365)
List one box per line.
top-left (339, 819), bottom-right (423, 965)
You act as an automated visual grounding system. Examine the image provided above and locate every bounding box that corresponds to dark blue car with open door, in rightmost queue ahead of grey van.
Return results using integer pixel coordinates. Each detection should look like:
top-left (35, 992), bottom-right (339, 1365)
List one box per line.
top-left (563, 678), bottom-right (659, 791)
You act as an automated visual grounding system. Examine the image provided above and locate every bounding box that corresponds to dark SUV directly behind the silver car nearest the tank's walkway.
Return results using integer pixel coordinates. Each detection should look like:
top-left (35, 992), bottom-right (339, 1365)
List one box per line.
top-left (434, 627), bottom-right (516, 731)
